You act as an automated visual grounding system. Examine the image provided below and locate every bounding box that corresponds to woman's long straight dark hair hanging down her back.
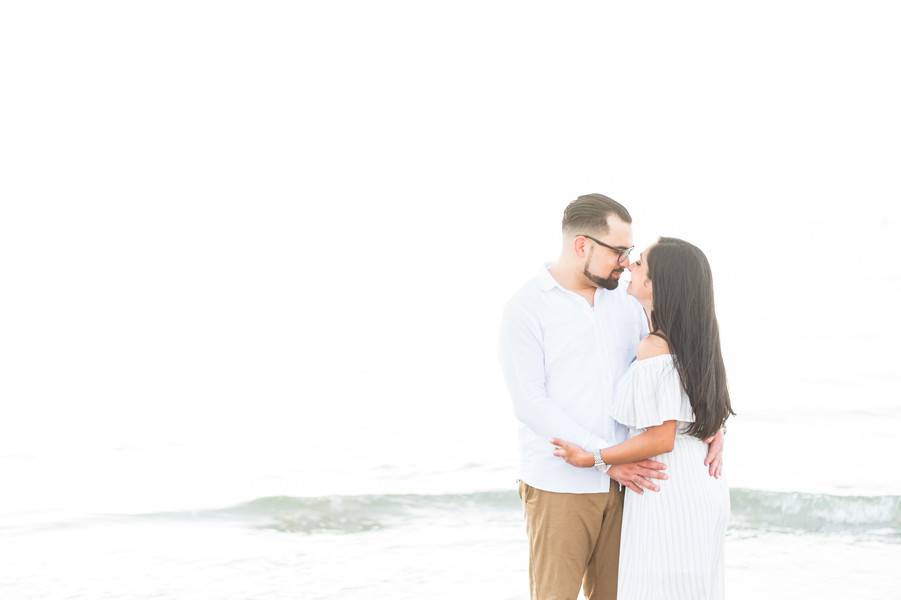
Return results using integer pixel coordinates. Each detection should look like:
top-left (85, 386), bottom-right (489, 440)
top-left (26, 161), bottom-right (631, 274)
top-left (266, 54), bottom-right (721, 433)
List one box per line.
top-left (645, 237), bottom-right (735, 439)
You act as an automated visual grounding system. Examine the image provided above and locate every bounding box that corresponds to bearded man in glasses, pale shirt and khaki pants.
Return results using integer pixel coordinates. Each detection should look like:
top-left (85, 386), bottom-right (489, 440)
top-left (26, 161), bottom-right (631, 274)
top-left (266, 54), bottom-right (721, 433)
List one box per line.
top-left (500, 194), bottom-right (722, 600)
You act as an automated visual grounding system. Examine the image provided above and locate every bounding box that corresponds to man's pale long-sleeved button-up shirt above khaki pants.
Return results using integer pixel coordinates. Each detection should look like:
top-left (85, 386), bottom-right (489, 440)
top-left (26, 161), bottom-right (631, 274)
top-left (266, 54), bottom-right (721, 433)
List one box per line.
top-left (500, 265), bottom-right (648, 494)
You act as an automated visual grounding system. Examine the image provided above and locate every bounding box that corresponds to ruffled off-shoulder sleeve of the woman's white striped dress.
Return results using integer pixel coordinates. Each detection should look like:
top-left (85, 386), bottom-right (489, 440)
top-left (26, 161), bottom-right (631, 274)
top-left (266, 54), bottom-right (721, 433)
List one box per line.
top-left (612, 356), bottom-right (695, 429)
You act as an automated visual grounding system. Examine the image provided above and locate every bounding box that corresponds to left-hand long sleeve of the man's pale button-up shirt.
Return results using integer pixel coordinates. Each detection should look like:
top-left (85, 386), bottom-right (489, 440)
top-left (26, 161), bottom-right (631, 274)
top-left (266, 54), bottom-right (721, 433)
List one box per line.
top-left (499, 303), bottom-right (614, 451)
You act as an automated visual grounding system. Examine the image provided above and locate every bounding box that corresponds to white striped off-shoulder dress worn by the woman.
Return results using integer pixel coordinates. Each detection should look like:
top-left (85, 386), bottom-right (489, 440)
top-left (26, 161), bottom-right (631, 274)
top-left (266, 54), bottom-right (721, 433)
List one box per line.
top-left (612, 354), bottom-right (730, 600)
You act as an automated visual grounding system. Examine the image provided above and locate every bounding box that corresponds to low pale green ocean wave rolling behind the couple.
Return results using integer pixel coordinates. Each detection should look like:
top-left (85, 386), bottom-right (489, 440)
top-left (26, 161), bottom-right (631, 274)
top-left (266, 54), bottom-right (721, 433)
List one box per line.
top-left (135, 488), bottom-right (901, 543)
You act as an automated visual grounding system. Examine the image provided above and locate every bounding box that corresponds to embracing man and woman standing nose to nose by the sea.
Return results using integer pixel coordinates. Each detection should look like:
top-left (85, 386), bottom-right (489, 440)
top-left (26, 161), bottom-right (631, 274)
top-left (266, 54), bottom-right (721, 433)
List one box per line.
top-left (500, 194), bottom-right (734, 600)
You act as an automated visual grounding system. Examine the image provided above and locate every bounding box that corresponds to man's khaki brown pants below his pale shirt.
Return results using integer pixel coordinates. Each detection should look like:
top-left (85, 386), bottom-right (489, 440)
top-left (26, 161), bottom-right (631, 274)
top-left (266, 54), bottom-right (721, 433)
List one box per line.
top-left (519, 480), bottom-right (623, 600)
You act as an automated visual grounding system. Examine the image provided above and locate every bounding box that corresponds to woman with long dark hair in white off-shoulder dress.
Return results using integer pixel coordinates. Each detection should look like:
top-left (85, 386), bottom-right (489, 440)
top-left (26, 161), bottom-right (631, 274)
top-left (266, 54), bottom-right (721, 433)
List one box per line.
top-left (554, 238), bottom-right (735, 600)
